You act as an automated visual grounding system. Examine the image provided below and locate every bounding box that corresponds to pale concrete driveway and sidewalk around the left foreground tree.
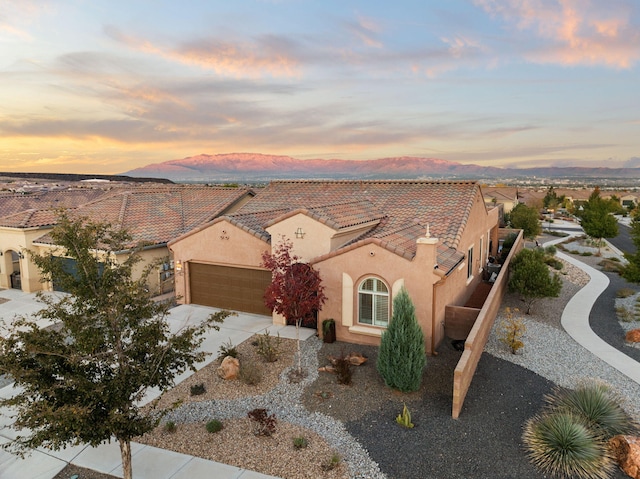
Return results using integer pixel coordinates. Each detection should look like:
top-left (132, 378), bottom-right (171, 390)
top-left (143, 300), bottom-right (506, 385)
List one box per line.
top-left (0, 290), bottom-right (315, 479)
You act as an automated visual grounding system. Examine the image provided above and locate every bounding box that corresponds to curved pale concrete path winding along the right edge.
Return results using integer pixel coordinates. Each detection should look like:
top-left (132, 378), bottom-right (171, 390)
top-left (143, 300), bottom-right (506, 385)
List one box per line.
top-left (545, 249), bottom-right (640, 384)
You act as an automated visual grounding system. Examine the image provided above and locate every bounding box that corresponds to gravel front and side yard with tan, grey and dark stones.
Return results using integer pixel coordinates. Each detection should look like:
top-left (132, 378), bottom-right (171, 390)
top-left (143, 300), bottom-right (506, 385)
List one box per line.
top-left (52, 251), bottom-right (640, 479)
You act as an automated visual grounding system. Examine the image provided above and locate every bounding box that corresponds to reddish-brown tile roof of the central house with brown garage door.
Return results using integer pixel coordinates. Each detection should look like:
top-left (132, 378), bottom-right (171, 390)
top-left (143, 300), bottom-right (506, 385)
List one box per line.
top-left (232, 180), bottom-right (479, 270)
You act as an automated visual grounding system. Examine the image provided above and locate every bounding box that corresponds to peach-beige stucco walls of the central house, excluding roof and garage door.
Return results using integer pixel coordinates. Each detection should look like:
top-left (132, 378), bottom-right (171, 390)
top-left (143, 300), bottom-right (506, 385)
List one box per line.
top-left (169, 191), bottom-right (498, 353)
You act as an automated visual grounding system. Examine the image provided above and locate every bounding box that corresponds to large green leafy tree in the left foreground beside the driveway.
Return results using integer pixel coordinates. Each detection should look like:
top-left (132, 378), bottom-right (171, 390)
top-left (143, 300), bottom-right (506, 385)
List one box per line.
top-left (0, 213), bottom-right (230, 479)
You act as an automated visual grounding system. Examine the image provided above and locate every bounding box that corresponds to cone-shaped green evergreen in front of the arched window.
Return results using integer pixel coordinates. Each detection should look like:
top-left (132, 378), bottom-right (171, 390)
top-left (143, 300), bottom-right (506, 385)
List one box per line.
top-left (376, 288), bottom-right (427, 392)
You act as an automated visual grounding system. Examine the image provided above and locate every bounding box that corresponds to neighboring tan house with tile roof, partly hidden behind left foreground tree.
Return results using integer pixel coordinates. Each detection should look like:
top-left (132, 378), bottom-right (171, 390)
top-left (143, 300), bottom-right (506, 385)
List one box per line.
top-left (0, 186), bottom-right (254, 293)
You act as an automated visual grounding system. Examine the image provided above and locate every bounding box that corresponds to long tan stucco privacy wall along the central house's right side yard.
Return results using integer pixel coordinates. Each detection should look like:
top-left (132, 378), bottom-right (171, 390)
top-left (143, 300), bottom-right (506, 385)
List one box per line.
top-left (451, 231), bottom-right (524, 419)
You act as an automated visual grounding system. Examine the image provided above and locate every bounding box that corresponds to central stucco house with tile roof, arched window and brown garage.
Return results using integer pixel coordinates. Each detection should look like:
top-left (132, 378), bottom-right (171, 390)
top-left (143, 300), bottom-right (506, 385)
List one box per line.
top-left (169, 181), bottom-right (499, 353)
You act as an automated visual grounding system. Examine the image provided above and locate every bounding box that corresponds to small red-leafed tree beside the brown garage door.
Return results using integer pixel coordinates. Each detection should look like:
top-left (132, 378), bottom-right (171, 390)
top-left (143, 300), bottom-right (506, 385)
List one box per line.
top-left (262, 236), bottom-right (327, 374)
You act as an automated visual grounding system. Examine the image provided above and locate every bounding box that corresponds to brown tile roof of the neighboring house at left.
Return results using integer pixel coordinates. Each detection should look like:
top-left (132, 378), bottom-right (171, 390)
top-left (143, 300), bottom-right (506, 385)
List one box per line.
top-left (16, 186), bottom-right (253, 249)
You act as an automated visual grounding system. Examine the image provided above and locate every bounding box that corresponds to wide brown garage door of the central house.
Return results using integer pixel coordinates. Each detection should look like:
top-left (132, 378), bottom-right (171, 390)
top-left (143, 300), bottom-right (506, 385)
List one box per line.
top-left (189, 263), bottom-right (271, 316)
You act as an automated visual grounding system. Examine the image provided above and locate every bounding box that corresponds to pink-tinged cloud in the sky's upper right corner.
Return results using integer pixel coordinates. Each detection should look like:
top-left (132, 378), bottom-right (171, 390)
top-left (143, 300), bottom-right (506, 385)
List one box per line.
top-left (474, 0), bottom-right (640, 68)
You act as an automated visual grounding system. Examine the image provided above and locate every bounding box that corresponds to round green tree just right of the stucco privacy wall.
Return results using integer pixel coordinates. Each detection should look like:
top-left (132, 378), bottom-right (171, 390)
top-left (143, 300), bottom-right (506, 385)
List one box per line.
top-left (509, 249), bottom-right (562, 314)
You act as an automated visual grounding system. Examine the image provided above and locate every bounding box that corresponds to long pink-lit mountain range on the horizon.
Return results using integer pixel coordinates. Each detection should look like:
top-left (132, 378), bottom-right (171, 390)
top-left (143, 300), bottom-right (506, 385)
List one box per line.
top-left (123, 153), bottom-right (640, 182)
